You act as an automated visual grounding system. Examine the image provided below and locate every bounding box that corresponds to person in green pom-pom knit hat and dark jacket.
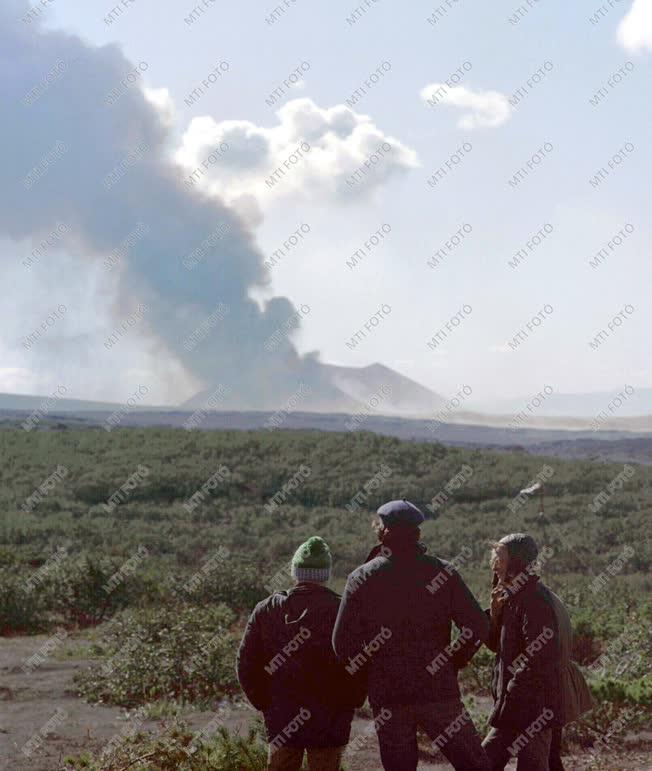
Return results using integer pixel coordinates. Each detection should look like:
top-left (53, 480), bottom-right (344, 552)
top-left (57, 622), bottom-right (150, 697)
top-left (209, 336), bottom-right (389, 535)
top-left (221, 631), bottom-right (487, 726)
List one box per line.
top-left (237, 536), bottom-right (366, 771)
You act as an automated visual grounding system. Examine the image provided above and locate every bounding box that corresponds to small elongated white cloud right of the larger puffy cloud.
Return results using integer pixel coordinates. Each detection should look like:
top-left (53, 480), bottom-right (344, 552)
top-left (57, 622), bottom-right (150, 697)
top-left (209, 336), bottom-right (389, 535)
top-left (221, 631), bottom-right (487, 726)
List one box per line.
top-left (419, 83), bottom-right (512, 130)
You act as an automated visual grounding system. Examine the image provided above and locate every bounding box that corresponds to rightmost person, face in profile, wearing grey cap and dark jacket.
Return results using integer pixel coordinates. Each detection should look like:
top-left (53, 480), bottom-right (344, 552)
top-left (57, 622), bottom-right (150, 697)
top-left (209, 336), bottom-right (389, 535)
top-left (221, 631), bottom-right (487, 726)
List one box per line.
top-left (483, 533), bottom-right (570, 771)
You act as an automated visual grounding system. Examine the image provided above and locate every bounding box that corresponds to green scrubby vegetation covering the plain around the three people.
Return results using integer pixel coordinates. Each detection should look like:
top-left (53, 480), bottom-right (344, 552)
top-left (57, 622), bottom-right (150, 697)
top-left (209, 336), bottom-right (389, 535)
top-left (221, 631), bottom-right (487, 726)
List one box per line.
top-left (0, 428), bottom-right (652, 769)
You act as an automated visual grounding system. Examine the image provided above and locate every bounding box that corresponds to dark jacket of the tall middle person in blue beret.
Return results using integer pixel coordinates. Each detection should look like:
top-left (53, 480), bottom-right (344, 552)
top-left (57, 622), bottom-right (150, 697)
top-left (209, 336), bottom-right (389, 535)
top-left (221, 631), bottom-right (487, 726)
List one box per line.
top-left (333, 544), bottom-right (489, 706)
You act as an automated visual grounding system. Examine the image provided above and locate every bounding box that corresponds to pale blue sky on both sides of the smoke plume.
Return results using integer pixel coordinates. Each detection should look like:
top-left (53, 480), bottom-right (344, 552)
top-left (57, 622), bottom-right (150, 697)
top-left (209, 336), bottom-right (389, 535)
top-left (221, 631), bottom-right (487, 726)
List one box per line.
top-left (0, 0), bottom-right (652, 405)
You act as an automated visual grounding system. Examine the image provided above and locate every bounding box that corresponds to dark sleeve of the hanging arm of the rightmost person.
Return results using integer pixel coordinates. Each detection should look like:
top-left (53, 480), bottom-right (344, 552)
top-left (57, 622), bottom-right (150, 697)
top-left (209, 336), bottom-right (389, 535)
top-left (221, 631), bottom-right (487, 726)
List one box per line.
top-left (506, 603), bottom-right (559, 704)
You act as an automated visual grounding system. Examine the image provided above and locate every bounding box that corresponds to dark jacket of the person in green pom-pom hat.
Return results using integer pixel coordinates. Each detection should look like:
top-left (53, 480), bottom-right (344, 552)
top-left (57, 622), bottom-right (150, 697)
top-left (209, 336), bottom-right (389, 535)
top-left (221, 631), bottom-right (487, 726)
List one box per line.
top-left (237, 583), bottom-right (366, 747)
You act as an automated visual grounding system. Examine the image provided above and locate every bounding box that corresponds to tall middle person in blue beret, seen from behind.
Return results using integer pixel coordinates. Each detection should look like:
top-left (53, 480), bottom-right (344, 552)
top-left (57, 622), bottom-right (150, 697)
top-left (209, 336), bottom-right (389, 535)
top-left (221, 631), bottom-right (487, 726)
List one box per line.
top-left (333, 500), bottom-right (489, 771)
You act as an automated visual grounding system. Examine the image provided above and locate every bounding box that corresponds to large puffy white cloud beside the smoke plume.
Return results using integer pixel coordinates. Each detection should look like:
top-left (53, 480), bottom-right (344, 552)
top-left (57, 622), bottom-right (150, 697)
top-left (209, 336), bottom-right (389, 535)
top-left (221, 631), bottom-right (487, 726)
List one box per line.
top-left (175, 98), bottom-right (419, 204)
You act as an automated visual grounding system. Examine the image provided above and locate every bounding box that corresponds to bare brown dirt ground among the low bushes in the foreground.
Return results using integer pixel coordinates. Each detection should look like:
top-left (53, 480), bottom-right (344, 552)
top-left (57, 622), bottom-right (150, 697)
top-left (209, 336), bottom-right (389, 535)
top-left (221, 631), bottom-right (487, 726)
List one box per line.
top-left (0, 636), bottom-right (652, 771)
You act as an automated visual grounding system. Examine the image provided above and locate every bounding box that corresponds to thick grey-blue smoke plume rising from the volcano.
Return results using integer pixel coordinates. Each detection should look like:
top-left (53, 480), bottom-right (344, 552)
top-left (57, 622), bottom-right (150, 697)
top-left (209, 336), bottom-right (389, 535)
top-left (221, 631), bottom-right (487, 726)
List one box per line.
top-left (0, 0), bottom-right (352, 408)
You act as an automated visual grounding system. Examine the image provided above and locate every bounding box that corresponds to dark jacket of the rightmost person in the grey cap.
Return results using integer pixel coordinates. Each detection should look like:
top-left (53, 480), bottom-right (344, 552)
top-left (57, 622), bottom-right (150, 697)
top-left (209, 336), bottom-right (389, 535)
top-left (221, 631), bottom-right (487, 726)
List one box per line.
top-left (487, 575), bottom-right (570, 731)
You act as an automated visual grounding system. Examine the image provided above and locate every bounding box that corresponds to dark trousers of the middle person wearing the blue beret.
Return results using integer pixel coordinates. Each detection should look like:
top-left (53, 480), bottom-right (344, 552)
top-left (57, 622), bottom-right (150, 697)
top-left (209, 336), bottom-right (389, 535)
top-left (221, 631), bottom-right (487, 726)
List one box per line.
top-left (373, 699), bottom-right (490, 771)
